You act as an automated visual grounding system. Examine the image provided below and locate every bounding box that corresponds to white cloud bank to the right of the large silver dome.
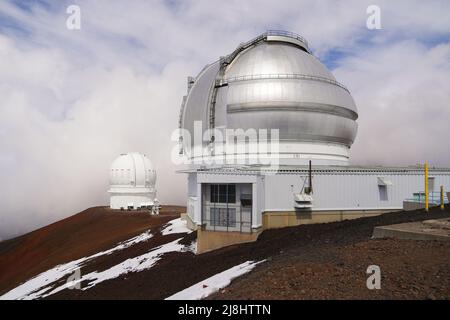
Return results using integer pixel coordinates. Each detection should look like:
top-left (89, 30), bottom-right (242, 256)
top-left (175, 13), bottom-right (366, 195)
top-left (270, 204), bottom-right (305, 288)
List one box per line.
top-left (335, 41), bottom-right (450, 166)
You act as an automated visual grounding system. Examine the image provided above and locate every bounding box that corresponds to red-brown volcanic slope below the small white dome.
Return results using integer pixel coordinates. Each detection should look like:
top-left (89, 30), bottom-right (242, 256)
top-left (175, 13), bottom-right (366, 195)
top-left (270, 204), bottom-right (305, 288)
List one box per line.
top-left (0, 206), bottom-right (185, 294)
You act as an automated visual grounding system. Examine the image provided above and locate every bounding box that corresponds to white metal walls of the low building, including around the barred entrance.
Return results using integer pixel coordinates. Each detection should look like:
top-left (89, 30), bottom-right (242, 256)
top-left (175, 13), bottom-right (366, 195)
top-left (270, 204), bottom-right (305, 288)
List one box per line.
top-left (188, 169), bottom-right (450, 228)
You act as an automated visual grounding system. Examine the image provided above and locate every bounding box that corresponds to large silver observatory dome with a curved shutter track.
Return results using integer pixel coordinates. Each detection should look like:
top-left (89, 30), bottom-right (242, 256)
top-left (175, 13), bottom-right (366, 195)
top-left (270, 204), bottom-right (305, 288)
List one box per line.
top-left (180, 31), bottom-right (358, 165)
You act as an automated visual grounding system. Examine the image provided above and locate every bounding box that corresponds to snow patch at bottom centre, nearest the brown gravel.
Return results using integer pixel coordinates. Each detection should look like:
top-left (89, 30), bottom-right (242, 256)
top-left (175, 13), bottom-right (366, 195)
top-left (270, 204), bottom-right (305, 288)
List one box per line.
top-left (165, 260), bottom-right (266, 300)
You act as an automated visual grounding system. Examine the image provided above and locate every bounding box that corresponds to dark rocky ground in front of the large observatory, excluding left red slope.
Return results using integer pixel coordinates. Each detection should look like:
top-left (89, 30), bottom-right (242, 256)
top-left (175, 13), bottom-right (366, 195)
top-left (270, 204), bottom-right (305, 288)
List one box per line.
top-left (0, 204), bottom-right (450, 299)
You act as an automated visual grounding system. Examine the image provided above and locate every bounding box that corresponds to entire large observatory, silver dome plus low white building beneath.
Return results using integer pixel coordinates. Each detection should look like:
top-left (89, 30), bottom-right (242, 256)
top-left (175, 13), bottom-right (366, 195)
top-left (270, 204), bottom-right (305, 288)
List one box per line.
top-left (179, 31), bottom-right (450, 252)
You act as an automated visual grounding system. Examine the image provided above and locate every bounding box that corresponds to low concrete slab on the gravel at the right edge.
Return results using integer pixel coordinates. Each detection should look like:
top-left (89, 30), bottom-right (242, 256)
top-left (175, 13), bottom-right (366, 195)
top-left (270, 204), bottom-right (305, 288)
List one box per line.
top-left (372, 218), bottom-right (450, 241)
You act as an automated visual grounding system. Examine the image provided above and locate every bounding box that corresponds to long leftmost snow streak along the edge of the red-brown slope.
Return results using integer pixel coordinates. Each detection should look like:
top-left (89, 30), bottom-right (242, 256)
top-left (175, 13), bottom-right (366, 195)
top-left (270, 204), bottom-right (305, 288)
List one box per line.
top-left (0, 231), bottom-right (153, 300)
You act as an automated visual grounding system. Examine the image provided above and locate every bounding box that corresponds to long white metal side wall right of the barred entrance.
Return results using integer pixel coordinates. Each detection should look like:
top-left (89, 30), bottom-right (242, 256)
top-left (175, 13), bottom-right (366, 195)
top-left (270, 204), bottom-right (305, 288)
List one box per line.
top-left (264, 171), bottom-right (450, 211)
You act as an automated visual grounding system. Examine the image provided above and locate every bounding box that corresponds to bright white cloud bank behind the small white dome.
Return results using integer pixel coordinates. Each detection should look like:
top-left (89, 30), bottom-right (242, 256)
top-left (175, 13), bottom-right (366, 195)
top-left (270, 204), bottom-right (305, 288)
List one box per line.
top-left (0, 32), bottom-right (189, 238)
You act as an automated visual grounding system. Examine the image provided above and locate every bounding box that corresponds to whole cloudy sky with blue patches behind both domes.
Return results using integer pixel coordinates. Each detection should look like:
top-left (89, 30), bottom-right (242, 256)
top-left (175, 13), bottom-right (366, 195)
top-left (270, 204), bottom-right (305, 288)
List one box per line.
top-left (0, 0), bottom-right (450, 238)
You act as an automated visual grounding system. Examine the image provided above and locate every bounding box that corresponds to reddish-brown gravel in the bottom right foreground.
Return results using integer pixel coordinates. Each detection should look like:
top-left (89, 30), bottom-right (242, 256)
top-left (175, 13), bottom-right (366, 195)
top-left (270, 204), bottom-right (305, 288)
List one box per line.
top-left (210, 239), bottom-right (450, 299)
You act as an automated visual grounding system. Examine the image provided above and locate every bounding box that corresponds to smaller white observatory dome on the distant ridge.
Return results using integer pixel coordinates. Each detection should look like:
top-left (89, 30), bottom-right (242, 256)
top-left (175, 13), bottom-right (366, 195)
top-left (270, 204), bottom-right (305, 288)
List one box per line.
top-left (108, 152), bottom-right (156, 210)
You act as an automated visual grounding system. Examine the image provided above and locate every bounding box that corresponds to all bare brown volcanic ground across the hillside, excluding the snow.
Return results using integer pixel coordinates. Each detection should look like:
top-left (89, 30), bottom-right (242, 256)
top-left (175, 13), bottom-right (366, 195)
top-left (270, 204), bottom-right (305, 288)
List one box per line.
top-left (0, 207), bottom-right (450, 299)
